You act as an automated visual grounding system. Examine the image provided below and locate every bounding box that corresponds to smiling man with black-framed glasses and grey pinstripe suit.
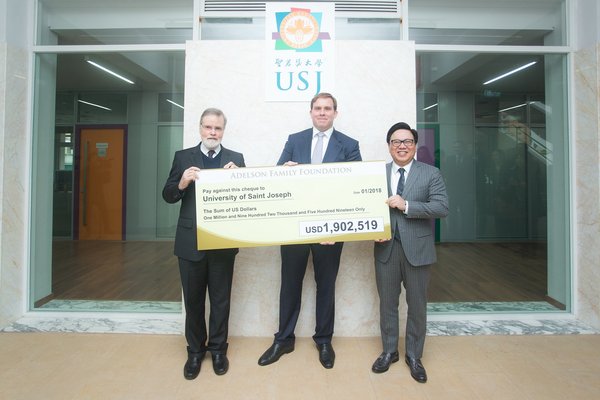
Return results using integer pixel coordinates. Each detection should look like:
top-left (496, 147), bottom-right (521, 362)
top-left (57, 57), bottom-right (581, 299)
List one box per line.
top-left (372, 122), bottom-right (448, 383)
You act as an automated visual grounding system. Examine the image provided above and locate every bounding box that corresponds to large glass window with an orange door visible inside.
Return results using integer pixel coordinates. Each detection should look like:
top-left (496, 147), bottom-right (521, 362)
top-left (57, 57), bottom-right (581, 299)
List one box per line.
top-left (32, 52), bottom-right (185, 312)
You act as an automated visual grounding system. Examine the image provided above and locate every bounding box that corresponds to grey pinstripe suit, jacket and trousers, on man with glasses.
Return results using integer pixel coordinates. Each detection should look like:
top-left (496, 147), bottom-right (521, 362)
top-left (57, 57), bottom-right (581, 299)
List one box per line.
top-left (374, 160), bottom-right (448, 359)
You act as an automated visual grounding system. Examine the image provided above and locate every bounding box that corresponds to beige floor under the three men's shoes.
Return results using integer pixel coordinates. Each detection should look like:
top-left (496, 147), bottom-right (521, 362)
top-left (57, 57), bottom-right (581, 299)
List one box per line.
top-left (0, 331), bottom-right (600, 400)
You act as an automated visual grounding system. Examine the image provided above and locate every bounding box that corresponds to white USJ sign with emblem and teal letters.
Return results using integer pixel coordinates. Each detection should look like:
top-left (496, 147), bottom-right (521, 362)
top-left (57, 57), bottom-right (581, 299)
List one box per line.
top-left (266, 3), bottom-right (335, 101)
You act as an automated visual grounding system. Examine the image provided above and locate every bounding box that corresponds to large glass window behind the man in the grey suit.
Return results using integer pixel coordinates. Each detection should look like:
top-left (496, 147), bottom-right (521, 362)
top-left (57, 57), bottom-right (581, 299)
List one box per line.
top-left (417, 52), bottom-right (570, 312)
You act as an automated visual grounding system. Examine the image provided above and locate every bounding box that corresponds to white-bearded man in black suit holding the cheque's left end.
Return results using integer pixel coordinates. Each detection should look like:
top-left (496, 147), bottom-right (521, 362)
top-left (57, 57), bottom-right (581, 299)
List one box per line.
top-left (162, 108), bottom-right (245, 379)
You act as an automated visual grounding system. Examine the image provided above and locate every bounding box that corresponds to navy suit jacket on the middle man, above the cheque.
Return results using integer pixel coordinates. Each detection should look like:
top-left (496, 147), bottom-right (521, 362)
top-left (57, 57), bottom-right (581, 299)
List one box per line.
top-left (277, 128), bottom-right (362, 165)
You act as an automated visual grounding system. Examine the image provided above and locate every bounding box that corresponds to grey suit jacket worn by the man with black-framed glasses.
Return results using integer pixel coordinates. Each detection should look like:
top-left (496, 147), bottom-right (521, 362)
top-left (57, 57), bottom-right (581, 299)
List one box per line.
top-left (375, 160), bottom-right (448, 266)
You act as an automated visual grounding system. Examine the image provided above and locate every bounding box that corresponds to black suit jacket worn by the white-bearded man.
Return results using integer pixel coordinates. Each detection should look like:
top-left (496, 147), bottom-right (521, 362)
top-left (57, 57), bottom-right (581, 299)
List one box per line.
top-left (162, 144), bottom-right (246, 261)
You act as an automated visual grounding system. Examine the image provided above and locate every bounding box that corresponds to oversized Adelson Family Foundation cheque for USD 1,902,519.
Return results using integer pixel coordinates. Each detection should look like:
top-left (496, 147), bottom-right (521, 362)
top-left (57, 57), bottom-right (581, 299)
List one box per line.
top-left (196, 161), bottom-right (391, 250)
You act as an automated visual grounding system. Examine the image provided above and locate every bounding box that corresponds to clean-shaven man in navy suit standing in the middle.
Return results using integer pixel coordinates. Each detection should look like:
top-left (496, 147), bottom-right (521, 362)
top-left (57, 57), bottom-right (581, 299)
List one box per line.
top-left (258, 93), bottom-right (361, 368)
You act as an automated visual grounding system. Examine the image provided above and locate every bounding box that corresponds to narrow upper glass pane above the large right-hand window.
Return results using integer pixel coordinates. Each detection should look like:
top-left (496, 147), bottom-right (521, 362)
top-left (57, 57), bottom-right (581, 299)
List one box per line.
top-left (408, 0), bottom-right (567, 46)
